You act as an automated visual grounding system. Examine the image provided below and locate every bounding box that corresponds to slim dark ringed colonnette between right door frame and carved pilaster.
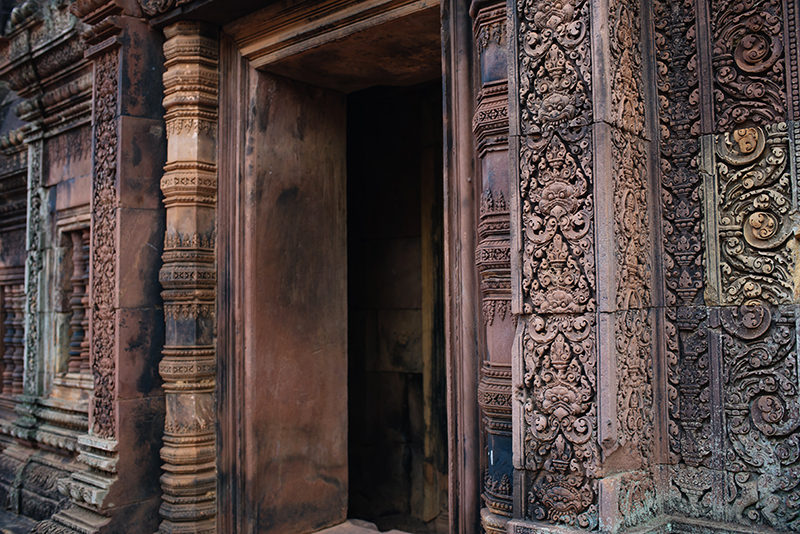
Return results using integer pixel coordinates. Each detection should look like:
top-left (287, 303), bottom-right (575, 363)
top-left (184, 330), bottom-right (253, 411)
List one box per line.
top-left (471, 2), bottom-right (514, 533)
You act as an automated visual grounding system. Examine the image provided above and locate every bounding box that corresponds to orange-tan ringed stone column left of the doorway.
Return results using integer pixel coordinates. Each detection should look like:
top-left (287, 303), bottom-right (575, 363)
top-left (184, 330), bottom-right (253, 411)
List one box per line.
top-left (159, 22), bottom-right (219, 533)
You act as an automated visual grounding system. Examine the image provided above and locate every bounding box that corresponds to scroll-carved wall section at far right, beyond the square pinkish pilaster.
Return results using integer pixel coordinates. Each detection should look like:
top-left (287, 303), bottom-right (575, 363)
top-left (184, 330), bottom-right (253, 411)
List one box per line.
top-left (654, 0), bottom-right (800, 531)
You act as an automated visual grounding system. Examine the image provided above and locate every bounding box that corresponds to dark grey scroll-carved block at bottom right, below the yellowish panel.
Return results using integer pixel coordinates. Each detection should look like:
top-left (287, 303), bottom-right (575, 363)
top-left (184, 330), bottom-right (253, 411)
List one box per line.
top-left (720, 302), bottom-right (800, 531)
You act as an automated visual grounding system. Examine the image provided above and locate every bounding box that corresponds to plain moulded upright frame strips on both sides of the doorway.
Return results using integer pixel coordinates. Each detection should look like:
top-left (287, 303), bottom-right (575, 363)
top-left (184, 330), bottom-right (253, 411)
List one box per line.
top-left (217, 0), bottom-right (481, 534)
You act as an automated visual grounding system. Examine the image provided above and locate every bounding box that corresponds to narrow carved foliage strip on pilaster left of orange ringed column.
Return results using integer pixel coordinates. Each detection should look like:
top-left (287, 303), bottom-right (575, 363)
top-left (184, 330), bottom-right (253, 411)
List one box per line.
top-left (90, 49), bottom-right (119, 438)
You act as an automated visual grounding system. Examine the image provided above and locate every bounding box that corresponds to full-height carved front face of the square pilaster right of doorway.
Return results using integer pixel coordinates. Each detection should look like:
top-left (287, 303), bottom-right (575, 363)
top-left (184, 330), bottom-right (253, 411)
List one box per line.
top-left (516, 0), bottom-right (598, 529)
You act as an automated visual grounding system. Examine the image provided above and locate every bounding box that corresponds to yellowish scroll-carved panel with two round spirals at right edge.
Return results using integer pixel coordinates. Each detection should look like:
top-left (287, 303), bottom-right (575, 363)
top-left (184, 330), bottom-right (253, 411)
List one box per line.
top-left (715, 123), bottom-right (794, 304)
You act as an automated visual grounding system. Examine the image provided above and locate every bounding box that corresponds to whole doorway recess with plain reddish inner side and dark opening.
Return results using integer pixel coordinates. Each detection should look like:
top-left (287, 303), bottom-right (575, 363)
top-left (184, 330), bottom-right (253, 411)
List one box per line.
top-left (221, 1), bottom-right (448, 534)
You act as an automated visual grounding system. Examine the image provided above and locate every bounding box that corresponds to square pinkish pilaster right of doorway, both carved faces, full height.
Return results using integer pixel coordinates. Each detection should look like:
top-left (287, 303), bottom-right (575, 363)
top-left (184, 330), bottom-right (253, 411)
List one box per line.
top-left (510, 0), bottom-right (659, 532)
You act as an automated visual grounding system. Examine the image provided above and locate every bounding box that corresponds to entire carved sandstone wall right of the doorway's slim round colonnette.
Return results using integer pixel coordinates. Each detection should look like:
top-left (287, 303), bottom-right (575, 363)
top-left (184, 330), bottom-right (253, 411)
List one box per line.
top-left (511, 0), bottom-right (800, 532)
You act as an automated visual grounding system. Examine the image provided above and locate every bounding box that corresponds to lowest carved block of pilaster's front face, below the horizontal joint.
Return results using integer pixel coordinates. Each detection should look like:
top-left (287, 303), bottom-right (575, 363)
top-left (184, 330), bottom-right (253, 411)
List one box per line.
top-left (523, 315), bottom-right (598, 529)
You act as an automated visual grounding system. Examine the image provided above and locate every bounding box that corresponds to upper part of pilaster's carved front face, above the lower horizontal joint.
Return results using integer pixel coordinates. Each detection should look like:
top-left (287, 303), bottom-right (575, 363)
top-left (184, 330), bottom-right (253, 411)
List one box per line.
top-left (517, 0), bottom-right (595, 313)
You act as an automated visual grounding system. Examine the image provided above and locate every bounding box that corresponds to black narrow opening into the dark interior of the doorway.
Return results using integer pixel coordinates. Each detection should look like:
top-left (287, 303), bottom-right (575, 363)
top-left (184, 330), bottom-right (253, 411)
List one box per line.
top-left (347, 81), bottom-right (447, 532)
